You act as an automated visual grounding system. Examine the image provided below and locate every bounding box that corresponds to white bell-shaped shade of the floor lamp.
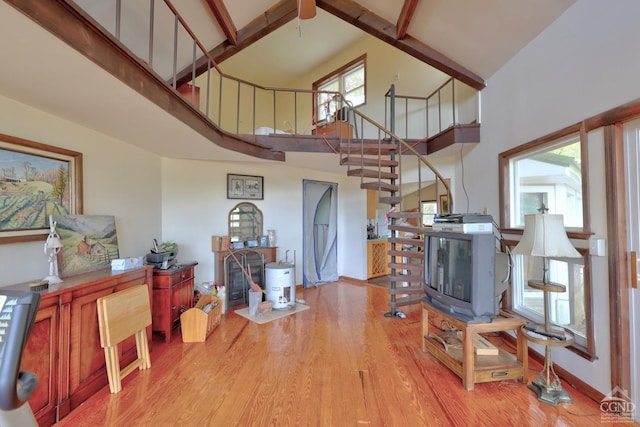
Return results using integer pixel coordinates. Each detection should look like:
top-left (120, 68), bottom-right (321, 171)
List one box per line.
top-left (512, 214), bottom-right (582, 258)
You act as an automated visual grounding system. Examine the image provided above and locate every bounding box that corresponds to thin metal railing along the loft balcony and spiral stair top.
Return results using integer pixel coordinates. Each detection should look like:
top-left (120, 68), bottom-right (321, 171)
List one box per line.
top-left (72, 0), bottom-right (452, 209)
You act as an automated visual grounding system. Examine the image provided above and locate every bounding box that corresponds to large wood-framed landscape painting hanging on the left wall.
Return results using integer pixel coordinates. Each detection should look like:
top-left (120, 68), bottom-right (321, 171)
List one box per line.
top-left (0, 134), bottom-right (82, 244)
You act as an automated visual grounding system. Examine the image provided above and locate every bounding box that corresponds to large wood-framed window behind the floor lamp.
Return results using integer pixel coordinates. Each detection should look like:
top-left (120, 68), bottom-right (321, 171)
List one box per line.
top-left (499, 125), bottom-right (595, 358)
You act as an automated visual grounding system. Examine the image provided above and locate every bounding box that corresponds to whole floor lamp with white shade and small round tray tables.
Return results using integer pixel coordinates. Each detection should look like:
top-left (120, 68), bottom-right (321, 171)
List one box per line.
top-left (512, 214), bottom-right (581, 405)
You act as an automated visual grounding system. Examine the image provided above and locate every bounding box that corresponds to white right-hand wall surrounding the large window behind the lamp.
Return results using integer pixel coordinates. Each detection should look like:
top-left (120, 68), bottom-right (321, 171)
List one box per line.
top-left (468, 0), bottom-right (640, 394)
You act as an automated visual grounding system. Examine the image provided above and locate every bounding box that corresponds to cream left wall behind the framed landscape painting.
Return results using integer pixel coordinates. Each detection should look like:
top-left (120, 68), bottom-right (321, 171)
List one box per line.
top-left (0, 96), bottom-right (162, 287)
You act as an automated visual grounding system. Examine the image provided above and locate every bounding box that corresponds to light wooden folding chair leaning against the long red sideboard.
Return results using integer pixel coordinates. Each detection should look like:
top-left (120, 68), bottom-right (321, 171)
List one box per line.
top-left (97, 285), bottom-right (151, 393)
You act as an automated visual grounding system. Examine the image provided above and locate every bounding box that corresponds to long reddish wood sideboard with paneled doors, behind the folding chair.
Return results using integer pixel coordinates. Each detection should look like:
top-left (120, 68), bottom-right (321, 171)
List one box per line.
top-left (6, 266), bottom-right (153, 426)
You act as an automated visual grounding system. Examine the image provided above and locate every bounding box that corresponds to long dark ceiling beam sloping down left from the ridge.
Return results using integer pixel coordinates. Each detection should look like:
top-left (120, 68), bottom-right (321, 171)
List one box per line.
top-left (177, 0), bottom-right (298, 86)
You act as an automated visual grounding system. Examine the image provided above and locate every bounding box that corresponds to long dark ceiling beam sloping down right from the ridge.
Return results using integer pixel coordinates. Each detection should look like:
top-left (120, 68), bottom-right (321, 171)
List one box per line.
top-left (316, 0), bottom-right (485, 90)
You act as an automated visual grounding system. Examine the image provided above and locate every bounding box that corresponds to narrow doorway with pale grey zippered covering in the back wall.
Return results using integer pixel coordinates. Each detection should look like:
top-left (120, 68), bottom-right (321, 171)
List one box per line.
top-left (302, 179), bottom-right (338, 288)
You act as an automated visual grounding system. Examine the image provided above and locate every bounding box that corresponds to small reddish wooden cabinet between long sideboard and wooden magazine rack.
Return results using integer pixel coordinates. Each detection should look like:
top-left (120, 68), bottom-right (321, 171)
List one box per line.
top-left (151, 262), bottom-right (198, 343)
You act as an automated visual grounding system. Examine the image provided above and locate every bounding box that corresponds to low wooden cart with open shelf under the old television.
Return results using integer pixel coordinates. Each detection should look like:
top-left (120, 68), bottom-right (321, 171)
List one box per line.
top-left (422, 301), bottom-right (528, 391)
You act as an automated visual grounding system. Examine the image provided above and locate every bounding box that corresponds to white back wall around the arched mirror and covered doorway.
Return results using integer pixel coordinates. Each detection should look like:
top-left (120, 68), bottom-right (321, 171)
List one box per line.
top-left (162, 157), bottom-right (367, 284)
